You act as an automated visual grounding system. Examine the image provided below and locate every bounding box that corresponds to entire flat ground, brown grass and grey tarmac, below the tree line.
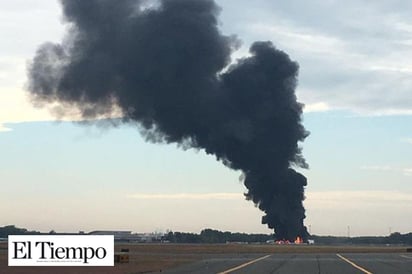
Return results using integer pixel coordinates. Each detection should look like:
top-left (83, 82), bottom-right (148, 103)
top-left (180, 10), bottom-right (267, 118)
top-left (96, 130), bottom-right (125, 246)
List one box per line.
top-left (0, 243), bottom-right (412, 274)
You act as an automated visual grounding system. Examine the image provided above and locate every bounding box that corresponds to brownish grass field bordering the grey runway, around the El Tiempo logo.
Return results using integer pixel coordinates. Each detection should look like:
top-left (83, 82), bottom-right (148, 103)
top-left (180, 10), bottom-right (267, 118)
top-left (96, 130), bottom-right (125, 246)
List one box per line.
top-left (0, 243), bottom-right (406, 274)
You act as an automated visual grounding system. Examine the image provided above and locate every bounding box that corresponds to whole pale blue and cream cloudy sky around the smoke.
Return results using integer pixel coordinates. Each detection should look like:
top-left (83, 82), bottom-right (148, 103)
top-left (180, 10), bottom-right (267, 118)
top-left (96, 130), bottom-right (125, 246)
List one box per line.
top-left (0, 0), bottom-right (412, 236)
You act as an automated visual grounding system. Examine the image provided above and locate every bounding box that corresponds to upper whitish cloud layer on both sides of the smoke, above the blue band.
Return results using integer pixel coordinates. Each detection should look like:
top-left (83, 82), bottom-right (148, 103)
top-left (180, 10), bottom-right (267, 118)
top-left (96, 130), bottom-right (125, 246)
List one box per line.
top-left (4, 0), bottom-right (412, 134)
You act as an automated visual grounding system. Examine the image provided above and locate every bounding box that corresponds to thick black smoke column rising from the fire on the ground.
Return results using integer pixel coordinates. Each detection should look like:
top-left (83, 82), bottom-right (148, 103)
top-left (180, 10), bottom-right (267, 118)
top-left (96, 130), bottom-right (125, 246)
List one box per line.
top-left (28, 0), bottom-right (308, 239)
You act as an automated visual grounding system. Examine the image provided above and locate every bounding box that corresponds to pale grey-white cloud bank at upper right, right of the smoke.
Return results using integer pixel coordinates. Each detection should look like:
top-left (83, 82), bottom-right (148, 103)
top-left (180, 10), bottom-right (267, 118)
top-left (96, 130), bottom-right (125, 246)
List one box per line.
top-left (222, 0), bottom-right (412, 116)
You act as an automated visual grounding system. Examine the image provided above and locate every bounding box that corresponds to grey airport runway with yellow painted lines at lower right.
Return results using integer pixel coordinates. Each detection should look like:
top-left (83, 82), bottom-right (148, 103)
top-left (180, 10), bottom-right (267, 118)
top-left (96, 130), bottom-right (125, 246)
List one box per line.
top-left (163, 253), bottom-right (412, 274)
